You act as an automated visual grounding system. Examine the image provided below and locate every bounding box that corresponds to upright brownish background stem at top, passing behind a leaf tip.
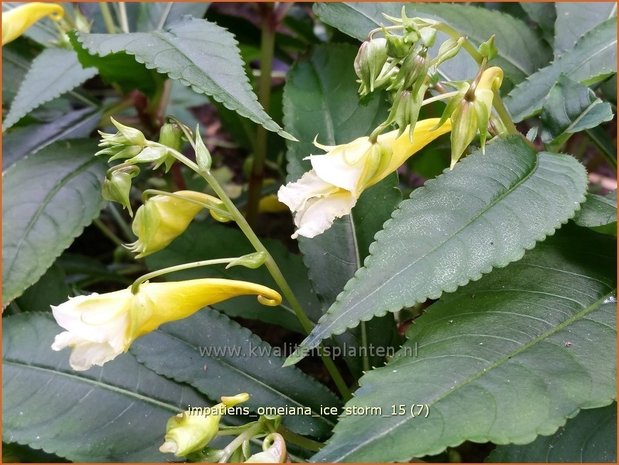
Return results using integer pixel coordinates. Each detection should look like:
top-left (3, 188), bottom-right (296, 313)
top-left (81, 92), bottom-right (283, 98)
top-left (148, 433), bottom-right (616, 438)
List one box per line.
top-left (245, 4), bottom-right (275, 225)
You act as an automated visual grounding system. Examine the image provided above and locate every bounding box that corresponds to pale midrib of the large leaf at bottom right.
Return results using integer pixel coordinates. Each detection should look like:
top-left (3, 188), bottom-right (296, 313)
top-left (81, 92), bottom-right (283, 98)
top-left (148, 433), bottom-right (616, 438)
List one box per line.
top-left (330, 288), bottom-right (616, 461)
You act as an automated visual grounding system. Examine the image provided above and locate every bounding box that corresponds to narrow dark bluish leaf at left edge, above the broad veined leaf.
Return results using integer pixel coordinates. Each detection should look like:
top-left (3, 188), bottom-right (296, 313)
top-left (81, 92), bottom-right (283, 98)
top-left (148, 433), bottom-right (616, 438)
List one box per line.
top-left (2, 107), bottom-right (101, 170)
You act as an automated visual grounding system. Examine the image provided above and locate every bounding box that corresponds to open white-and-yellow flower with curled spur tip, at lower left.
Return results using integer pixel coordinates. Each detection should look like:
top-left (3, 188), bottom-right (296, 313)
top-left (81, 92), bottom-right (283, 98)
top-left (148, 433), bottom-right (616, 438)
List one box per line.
top-left (52, 279), bottom-right (281, 371)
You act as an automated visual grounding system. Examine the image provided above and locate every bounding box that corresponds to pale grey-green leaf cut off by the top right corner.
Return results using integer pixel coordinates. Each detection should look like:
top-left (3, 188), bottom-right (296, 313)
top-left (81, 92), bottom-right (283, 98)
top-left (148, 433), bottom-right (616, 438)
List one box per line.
top-left (554, 2), bottom-right (617, 58)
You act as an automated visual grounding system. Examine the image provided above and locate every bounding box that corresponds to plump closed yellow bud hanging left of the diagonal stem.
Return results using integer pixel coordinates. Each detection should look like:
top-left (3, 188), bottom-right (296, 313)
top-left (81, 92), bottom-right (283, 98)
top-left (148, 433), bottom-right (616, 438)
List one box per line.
top-left (128, 191), bottom-right (228, 258)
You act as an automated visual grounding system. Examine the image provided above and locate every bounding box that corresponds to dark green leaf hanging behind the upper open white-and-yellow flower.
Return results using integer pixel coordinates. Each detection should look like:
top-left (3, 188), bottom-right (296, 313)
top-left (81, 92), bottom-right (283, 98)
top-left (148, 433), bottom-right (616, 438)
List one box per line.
top-left (284, 44), bottom-right (401, 374)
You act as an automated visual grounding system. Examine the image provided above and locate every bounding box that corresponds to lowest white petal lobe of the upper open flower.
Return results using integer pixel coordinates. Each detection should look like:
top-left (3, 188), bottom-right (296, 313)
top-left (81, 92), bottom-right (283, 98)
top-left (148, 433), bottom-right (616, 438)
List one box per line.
top-left (292, 190), bottom-right (357, 239)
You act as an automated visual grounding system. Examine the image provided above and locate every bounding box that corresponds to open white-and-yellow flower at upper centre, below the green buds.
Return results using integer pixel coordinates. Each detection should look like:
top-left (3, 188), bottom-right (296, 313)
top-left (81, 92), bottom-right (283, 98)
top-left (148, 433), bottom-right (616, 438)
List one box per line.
top-left (278, 118), bottom-right (451, 238)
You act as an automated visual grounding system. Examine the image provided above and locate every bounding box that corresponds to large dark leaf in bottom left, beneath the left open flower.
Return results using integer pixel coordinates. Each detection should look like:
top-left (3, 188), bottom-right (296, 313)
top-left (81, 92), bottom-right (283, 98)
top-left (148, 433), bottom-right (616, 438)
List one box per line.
top-left (2, 313), bottom-right (212, 462)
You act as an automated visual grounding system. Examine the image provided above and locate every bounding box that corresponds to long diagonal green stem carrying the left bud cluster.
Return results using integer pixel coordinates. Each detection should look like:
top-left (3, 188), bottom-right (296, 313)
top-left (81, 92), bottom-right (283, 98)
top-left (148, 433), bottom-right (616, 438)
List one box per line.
top-left (160, 144), bottom-right (351, 400)
